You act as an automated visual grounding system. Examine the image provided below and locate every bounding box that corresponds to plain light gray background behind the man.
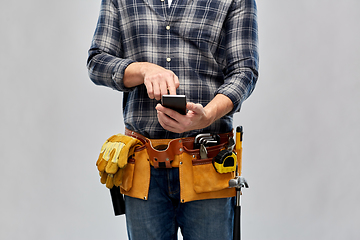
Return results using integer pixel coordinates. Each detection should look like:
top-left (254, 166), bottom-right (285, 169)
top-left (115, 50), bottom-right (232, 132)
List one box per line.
top-left (0, 0), bottom-right (360, 240)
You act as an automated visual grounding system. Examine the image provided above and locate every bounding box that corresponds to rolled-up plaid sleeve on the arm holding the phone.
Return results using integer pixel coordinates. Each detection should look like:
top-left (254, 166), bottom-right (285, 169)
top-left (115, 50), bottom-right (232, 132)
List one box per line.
top-left (215, 0), bottom-right (259, 114)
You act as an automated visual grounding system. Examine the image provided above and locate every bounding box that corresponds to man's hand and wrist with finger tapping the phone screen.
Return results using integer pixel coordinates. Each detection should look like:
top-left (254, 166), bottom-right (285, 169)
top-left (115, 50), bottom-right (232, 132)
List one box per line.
top-left (124, 62), bottom-right (180, 100)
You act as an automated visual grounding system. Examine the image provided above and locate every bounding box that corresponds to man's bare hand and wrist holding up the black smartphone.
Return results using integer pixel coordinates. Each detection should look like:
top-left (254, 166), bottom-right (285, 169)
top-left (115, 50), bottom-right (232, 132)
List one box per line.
top-left (156, 94), bottom-right (234, 133)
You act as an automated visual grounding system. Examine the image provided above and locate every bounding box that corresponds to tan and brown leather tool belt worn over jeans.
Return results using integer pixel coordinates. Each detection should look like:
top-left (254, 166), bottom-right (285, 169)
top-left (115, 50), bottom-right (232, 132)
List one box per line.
top-left (120, 129), bottom-right (236, 203)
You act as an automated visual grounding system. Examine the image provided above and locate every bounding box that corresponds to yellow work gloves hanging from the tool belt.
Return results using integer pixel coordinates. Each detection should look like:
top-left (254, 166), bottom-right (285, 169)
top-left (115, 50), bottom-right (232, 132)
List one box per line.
top-left (96, 134), bottom-right (141, 188)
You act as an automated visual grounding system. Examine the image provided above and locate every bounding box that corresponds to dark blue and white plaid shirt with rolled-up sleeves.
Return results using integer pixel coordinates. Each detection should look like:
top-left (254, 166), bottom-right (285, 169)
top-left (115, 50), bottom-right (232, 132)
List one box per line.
top-left (87, 0), bottom-right (258, 138)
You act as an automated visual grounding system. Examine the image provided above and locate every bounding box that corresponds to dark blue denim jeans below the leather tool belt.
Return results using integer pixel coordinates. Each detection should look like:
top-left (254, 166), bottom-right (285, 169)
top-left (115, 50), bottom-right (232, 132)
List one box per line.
top-left (125, 167), bottom-right (235, 240)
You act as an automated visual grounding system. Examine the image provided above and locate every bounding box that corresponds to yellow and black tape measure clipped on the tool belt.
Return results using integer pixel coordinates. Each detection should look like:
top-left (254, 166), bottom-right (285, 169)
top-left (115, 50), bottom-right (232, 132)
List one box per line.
top-left (213, 150), bottom-right (237, 173)
